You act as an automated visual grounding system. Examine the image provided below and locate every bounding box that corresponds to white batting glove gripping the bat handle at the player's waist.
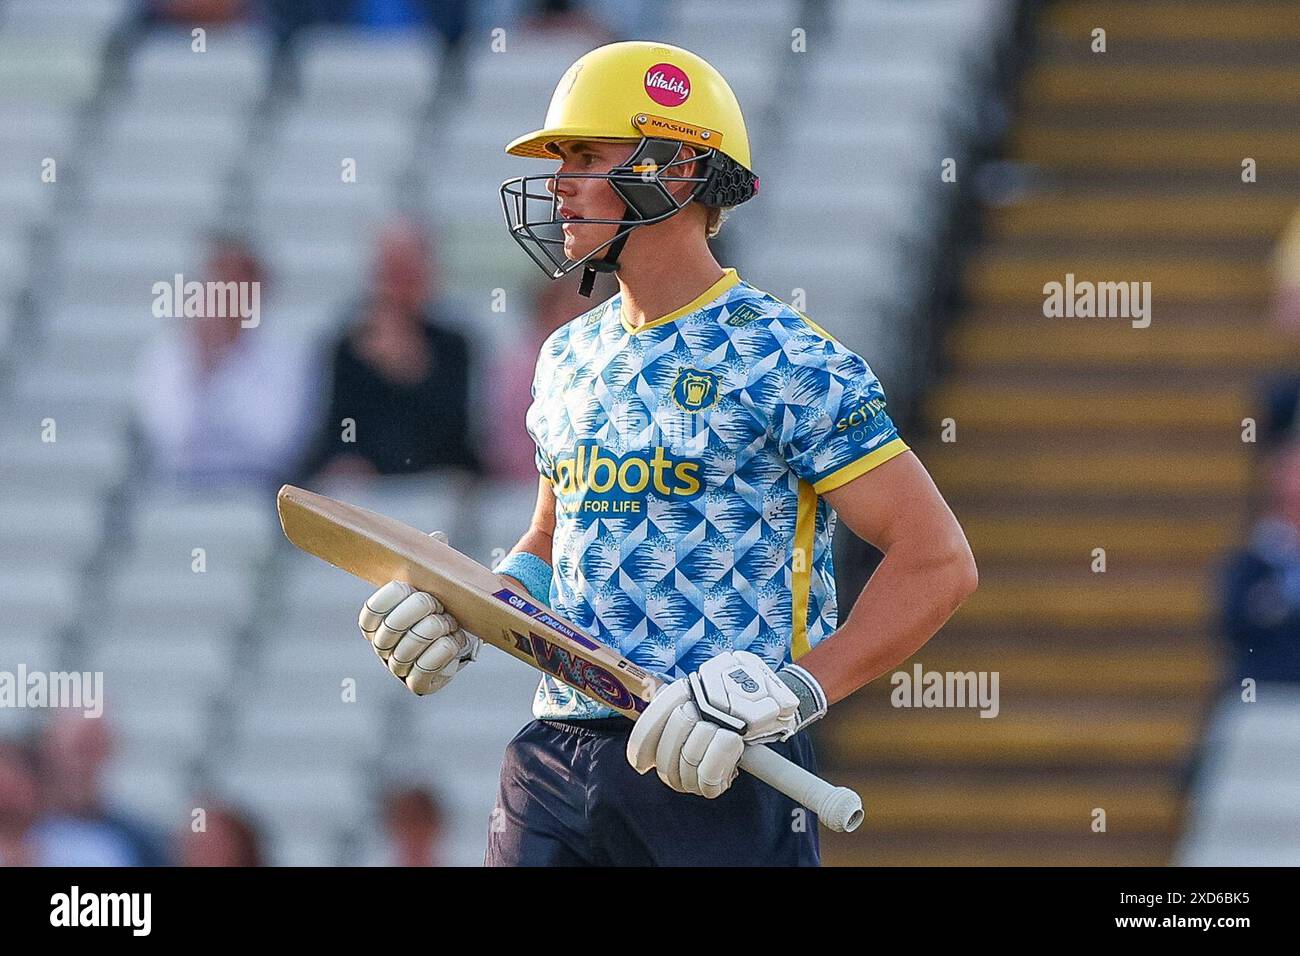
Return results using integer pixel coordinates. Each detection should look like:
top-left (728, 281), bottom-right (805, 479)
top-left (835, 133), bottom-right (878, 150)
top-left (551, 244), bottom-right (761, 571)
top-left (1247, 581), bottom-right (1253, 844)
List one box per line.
top-left (628, 650), bottom-right (801, 799)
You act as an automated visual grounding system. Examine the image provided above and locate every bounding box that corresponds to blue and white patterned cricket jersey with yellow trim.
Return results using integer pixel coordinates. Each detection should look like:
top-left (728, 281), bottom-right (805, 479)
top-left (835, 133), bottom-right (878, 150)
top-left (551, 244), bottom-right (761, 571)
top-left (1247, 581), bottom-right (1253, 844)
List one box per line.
top-left (528, 269), bottom-right (907, 718)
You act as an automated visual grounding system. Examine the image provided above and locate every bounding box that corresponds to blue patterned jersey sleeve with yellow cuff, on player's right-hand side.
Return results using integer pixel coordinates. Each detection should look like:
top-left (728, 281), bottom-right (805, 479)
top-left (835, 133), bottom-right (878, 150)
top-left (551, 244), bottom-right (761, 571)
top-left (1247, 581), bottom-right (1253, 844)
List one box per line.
top-left (761, 326), bottom-right (907, 494)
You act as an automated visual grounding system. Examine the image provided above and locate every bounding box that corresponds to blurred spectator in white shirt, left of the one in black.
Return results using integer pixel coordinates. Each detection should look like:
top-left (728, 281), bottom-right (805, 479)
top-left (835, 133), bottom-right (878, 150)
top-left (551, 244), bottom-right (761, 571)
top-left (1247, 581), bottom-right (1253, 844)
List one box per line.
top-left (135, 237), bottom-right (319, 485)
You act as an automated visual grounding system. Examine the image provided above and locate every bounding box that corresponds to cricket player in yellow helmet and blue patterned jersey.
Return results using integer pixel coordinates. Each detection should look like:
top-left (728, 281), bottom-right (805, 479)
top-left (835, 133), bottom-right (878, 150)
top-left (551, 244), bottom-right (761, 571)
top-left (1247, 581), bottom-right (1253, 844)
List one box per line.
top-left (360, 42), bottom-right (976, 865)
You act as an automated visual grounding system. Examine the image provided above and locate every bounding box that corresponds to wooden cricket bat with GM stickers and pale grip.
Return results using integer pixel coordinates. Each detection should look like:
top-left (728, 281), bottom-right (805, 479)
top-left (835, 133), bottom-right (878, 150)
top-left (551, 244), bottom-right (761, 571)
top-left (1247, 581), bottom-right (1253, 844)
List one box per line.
top-left (276, 485), bottom-right (863, 832)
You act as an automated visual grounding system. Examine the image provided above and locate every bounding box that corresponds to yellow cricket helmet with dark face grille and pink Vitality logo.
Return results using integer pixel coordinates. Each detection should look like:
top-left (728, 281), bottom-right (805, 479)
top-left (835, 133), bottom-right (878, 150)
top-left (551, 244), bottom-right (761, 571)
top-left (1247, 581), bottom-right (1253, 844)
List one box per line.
top-left (501, 40), bottom-right (758, 295)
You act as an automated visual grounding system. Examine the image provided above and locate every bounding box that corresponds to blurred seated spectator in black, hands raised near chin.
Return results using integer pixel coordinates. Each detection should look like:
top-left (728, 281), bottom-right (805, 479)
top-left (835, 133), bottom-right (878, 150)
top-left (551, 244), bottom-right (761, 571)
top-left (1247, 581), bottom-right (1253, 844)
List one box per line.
top-left (311, 221), bottom-right (480, 476)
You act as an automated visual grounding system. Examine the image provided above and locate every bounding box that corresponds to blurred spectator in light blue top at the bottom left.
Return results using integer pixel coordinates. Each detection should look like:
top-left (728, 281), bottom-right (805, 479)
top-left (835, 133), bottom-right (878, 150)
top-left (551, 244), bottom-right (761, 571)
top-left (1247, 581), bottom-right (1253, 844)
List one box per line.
top-left (33, 713), bottom-right (165, 866)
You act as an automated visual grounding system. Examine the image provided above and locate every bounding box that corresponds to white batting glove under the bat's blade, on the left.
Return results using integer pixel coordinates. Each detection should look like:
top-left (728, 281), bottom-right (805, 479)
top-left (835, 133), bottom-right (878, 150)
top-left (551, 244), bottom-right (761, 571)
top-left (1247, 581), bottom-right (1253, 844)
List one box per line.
top-left (358, 538), bottom-right (482, 697)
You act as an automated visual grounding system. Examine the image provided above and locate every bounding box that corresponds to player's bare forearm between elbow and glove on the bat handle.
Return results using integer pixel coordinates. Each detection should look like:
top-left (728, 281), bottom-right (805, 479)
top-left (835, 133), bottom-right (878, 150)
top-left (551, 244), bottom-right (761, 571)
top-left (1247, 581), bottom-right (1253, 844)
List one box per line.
top-left (798, 537), bottom-right (976, 704)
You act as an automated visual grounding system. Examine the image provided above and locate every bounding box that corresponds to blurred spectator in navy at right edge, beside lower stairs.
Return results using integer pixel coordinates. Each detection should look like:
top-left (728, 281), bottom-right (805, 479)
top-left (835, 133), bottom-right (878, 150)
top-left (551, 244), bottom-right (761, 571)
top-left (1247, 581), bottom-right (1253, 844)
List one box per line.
top-left (1222, 441), bottom-right (1300, 682)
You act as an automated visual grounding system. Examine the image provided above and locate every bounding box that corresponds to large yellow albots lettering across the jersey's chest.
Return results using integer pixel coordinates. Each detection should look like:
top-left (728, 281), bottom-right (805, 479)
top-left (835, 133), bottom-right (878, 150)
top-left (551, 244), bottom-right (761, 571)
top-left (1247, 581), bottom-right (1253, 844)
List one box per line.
top-left (555, 440), bottom-right (703, 510)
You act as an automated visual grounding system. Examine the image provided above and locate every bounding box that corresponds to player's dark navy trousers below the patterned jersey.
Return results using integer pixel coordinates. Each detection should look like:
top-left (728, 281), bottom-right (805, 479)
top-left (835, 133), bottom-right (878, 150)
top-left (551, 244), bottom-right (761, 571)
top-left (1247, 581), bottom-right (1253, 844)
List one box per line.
top-left (484, 717), bottom-right (820, 866)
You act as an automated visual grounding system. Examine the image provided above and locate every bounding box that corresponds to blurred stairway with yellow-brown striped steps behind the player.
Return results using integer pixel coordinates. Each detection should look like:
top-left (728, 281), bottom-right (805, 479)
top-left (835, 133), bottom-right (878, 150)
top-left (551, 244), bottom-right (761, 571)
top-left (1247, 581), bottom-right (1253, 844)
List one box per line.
top-left (819, 0), bottom-right (1300, 865)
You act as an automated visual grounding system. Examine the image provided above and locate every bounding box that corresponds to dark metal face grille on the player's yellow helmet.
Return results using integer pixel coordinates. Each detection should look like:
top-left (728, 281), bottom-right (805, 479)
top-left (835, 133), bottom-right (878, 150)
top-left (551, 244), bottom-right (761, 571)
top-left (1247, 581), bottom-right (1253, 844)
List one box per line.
top-left (501, 137), bottom-right (758, 278)
